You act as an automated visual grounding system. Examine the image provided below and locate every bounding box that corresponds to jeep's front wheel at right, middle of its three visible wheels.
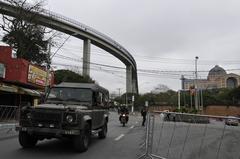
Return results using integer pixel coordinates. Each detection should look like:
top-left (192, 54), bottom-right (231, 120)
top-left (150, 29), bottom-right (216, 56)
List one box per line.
top-left (73, 124), bottom-right (91, 152)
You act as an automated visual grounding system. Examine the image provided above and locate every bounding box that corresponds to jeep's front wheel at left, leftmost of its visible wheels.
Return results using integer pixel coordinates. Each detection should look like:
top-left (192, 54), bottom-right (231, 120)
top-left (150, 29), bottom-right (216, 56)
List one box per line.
top-left (18, 131), bottom-right (38, 148)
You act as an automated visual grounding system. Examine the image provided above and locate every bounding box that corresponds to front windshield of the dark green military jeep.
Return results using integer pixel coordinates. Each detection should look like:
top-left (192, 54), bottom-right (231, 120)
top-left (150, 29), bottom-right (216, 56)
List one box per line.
top-left (47, 87), bottom-right (92, 104)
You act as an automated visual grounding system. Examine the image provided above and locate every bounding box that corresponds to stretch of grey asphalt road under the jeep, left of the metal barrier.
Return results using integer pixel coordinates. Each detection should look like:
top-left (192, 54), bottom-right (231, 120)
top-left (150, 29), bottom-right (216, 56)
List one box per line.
top-left (0, 112), bottom-right (145, 159)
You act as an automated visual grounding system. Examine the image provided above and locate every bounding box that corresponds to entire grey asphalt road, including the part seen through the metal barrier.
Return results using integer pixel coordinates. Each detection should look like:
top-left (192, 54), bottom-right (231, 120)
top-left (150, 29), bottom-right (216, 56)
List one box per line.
top-left (0, 112), bottom-right (240, 159)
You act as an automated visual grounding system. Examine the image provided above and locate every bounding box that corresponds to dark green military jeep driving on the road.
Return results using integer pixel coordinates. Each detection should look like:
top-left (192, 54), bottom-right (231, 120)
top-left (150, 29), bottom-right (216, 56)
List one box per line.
top-left (17, 82), bottom-right (109, 152)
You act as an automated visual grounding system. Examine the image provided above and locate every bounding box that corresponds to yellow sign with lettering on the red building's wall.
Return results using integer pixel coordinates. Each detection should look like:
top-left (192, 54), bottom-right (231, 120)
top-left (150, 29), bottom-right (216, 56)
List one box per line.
top-left (28, 65), bottom-right (47, 86)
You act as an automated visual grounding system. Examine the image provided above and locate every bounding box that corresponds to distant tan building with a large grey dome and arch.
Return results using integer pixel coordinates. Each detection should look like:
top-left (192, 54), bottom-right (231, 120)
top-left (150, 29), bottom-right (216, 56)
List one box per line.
top-left (181, 65), bottom-right (240, 90)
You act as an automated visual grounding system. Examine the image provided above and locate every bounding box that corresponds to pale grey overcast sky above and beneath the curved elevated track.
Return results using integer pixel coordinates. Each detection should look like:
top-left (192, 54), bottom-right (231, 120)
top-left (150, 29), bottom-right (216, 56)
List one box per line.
top-left (2, 0), bottom-right (240, 93)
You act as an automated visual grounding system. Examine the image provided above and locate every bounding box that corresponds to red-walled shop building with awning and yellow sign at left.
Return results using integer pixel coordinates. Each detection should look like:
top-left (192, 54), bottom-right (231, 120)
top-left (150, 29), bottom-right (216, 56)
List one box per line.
top-left (0, 46), bottom-right (54, 106)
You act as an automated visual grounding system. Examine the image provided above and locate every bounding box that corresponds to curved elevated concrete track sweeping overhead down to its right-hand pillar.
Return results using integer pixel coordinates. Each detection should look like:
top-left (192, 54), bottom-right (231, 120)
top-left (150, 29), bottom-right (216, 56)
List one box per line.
top-left (0, 0), bottom-right (138, 93)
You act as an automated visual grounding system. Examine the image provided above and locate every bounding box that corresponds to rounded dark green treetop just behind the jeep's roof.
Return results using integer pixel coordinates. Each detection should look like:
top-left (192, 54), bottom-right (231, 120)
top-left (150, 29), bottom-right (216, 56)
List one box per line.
top-left (54, 70), bottom-right (95, 84)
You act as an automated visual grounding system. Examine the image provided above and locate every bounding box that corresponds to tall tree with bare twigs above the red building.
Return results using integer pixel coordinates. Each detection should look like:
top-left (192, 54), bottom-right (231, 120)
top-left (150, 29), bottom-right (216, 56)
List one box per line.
top-left (0, 0), bottom-right (50, 65)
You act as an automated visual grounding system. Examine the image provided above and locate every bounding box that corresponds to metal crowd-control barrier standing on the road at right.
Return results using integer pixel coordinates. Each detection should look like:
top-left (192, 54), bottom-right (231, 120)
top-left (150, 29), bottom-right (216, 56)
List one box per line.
top-left (139, 111), bottom-right (240, 159)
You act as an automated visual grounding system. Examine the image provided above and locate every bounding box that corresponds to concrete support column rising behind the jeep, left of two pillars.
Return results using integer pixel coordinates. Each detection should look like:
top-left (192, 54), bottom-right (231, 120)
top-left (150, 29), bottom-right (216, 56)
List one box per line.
top-left (82, 39), bottom-right (91, 77)
